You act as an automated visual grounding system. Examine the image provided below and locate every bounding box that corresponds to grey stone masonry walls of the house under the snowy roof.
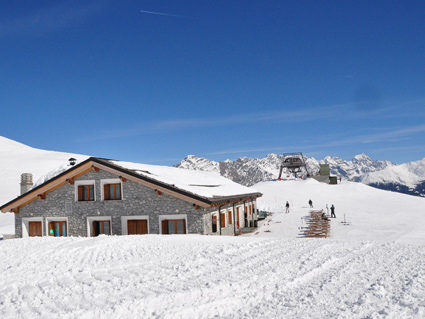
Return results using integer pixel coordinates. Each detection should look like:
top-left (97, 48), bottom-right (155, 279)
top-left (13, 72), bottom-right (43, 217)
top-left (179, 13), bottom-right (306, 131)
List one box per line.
top-left (15, 170), bottom-right (256, 237)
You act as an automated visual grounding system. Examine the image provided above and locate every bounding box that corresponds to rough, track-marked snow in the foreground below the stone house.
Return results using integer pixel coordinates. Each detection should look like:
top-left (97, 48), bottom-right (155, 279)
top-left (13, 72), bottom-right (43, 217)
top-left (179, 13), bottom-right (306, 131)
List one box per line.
top-left (0, 235), bottom-right (425, 318)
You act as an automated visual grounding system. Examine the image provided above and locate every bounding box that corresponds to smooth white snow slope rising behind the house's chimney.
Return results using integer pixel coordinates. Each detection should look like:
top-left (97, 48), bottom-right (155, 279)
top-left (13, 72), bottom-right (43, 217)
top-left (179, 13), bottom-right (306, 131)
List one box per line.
top-left (0, 136), bottom-right (88, 234)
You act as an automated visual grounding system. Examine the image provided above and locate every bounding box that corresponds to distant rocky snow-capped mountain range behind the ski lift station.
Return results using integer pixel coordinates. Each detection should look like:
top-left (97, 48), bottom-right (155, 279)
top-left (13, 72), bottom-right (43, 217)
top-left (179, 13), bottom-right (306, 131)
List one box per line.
top-left (175, 154), bottom-right (425, 196)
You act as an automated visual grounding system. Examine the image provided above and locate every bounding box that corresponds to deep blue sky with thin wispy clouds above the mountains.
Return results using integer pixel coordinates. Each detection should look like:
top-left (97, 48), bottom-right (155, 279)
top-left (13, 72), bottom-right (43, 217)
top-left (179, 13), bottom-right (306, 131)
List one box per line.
top-left (0, 0), bottom-right (425, 165)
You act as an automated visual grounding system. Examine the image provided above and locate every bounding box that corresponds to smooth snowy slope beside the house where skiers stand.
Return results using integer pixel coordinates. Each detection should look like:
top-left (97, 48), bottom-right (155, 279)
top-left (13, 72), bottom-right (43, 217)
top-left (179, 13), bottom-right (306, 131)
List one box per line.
top-left (253, 179), bottom-right (425, 245)
